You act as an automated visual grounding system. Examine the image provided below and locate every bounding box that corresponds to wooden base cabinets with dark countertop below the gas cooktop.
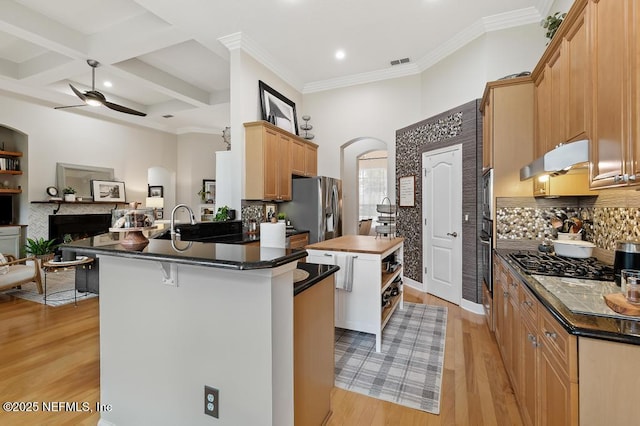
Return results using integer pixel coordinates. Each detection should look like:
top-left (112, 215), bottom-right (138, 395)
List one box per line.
top-left (493, 249), bottom-right (640, 425)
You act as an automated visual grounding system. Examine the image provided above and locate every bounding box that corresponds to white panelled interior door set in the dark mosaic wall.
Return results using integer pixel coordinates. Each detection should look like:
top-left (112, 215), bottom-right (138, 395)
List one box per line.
top-left (422, 145), bottom-right (462, 305)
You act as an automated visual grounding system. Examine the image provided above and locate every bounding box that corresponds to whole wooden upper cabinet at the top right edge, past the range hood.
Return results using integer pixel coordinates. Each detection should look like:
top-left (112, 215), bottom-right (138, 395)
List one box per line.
top-left (588, 0), bottom-right (640, 188)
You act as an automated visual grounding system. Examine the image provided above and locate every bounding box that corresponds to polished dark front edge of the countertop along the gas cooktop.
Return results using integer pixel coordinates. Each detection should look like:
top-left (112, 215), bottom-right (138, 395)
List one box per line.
top-left (495, 249), bottom-right (640, 345)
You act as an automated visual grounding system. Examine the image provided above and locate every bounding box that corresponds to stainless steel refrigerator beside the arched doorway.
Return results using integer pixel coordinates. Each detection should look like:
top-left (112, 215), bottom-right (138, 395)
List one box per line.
top-left (278, 176), bottom-right (342, 243)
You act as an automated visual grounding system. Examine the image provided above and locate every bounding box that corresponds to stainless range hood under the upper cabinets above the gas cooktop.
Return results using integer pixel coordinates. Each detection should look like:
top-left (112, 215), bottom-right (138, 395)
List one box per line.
top-left (520, 139), bottom-right (589, 180)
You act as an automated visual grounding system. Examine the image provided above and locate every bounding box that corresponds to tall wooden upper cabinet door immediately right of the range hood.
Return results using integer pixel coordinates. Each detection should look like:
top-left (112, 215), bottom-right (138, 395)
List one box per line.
top-left (588, 0), bottom-right (634, 187)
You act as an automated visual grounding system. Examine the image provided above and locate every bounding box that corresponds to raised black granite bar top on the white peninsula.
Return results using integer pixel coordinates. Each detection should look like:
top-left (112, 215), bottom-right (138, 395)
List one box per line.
top-left (60, 231), bottom-right (307, 270)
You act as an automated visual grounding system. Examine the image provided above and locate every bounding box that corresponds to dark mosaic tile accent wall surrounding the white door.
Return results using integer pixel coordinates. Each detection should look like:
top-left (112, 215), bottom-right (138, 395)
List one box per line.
top-left (396, 101), bottom-right (482, 302)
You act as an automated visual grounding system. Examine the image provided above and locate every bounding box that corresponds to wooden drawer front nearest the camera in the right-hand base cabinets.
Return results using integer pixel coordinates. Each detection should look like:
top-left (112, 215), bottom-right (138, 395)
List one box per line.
top-left (538, 309), bottom-right (578, 382)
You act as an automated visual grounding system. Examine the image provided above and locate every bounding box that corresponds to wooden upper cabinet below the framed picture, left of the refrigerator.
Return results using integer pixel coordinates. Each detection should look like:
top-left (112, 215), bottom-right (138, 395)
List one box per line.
top-left (244, 122), bottom-right (291, 201)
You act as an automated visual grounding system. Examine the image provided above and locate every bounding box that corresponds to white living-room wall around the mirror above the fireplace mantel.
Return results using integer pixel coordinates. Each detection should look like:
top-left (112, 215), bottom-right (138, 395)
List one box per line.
top-left (0, 94), bottom-right (176, 210)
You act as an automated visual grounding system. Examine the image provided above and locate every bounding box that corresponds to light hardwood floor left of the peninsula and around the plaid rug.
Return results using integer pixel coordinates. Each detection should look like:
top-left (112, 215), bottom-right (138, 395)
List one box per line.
top-left (0, 289), bottom-right (522, 426)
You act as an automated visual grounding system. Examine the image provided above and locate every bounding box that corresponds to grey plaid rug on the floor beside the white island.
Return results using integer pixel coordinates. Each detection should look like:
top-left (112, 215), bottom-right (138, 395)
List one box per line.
top-left (335, 302), bottom-right (447, 414)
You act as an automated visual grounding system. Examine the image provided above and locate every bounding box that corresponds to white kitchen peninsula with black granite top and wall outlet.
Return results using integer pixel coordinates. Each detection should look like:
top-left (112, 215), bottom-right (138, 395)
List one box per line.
top-left (63, 233), bottom-right (337, 425)
